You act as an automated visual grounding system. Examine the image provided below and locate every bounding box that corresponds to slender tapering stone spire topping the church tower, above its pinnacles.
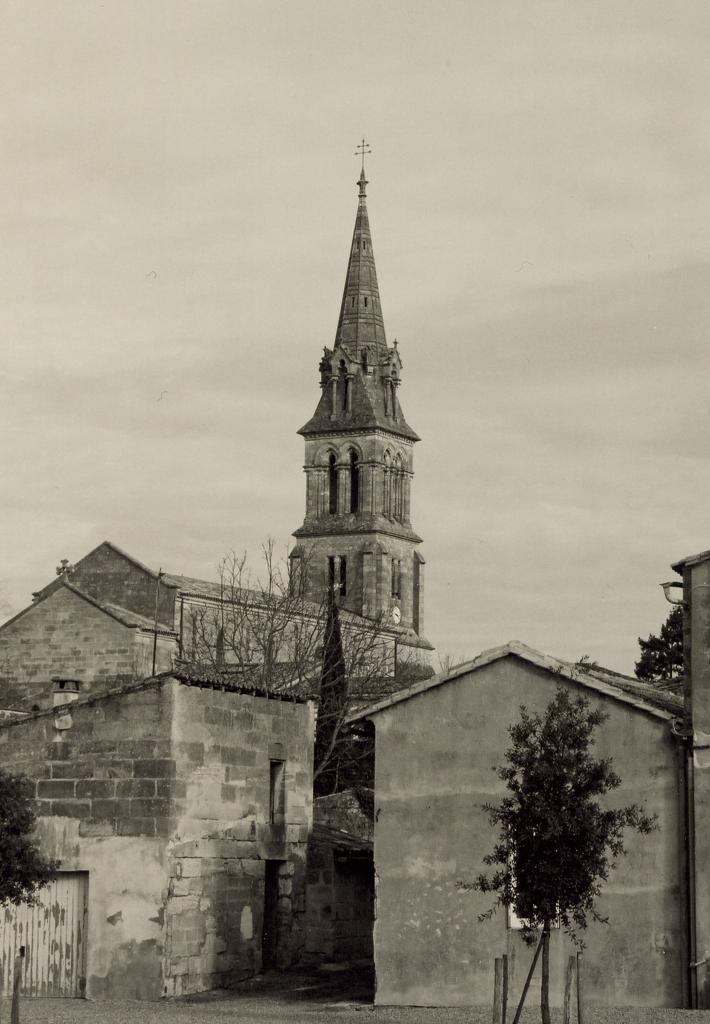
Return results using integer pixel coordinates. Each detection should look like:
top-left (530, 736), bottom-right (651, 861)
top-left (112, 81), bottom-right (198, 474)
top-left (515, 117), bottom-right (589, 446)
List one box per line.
top-left (335, 165), bottom-right (387, 360)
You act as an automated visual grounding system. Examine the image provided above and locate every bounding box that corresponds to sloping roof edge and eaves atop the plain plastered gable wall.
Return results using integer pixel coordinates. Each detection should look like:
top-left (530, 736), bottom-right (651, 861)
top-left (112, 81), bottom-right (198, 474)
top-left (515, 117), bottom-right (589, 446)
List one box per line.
top-left (347, 640), bottom-right (683, 722)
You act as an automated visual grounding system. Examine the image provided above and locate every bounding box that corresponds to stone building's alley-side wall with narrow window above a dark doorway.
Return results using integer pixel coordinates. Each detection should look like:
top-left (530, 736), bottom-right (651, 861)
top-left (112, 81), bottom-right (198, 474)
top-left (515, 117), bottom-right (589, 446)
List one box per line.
top-left (166, 684), bottom-right (312, 994)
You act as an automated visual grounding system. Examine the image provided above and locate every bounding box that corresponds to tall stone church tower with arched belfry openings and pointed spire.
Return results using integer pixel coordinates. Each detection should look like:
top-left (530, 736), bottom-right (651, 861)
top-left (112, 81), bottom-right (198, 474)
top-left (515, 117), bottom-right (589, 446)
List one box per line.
top-left (291, 167), bottom-right (429, 647)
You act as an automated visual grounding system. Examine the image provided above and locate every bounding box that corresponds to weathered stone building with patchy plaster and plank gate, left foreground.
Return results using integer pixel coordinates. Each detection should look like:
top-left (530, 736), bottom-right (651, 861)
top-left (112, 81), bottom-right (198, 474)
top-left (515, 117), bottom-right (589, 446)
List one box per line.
top-left (0, 672), bottom-right (314, 999)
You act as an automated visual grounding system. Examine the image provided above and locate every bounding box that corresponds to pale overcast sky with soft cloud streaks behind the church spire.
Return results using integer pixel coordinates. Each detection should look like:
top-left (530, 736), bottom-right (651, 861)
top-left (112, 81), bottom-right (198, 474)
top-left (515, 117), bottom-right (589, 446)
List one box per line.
top-left (0, 0), bottom-right (710, 672)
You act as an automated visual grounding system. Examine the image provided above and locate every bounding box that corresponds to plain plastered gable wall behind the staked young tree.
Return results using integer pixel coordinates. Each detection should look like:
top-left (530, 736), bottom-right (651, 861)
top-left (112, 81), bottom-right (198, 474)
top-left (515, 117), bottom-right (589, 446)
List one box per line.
top-left (374, 657), bottom-right (681, 1006)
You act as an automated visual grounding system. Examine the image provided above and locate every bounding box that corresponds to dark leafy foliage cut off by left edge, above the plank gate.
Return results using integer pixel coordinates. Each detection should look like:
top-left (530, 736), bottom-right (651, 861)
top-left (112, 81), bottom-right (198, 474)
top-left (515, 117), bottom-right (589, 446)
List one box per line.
top-left (0, 770), bottom-right (59, 904)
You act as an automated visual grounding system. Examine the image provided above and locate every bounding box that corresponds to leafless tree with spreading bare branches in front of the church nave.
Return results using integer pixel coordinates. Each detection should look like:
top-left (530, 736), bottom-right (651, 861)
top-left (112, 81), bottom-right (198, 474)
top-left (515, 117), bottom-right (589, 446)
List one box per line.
top-left (183, 540), bottom-right (430, 792)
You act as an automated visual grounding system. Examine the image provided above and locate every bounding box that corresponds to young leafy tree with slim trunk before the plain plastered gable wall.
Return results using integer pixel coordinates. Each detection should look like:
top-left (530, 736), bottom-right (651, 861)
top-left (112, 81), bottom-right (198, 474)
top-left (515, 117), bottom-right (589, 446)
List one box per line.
top-left (463, 687), bottom-right (657, 1024)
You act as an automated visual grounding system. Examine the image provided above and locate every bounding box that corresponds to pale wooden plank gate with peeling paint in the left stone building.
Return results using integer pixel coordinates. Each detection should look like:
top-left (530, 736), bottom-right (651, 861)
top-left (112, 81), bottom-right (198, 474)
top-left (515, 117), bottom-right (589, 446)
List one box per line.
top-left (0, 871), bottom-right (89, 998)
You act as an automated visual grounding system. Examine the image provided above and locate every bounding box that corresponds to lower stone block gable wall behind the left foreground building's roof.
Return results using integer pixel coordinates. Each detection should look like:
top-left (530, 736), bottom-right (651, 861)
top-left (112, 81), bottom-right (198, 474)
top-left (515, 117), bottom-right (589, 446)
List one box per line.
top-left (0, 587), bottom-right (175, 711)
